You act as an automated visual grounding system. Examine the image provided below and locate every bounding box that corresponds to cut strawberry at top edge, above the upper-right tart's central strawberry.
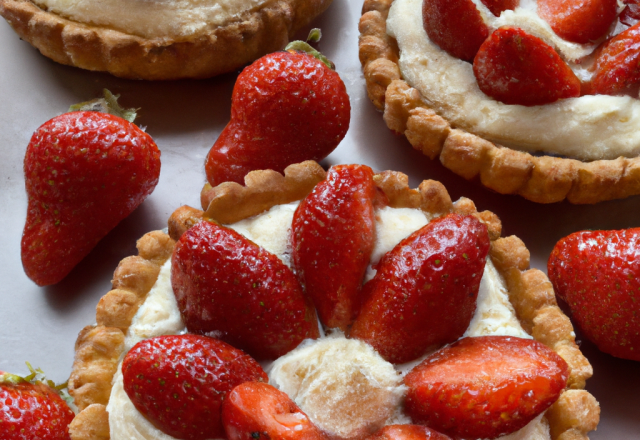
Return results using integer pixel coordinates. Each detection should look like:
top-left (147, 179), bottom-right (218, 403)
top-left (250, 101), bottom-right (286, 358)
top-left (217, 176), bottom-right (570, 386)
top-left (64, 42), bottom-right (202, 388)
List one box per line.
top-left (538, 0), bottom-right (618, 44)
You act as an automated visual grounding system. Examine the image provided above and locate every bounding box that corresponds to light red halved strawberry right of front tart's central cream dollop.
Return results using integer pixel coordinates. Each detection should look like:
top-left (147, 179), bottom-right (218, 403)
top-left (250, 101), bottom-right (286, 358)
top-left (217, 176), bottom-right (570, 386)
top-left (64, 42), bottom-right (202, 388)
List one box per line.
top-left (405, 336), bottom-right (569, 438)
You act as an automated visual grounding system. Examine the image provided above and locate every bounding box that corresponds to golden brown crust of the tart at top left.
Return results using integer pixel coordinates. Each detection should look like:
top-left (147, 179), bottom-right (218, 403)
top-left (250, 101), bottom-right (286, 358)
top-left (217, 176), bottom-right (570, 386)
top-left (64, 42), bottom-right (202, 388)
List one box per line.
top-left (0, 0), bottom-right (331, 80)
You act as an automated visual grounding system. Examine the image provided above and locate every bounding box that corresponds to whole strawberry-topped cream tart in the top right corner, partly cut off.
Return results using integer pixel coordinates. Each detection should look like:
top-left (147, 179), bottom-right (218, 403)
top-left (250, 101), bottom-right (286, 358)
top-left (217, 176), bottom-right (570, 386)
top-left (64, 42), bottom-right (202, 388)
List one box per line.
top-left (360, 0), bottom-right (640, 203)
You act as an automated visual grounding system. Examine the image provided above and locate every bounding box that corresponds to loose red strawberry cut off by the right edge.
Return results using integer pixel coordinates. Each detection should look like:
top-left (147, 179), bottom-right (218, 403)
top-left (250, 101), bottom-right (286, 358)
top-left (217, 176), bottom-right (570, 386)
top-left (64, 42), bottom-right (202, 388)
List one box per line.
top-left (548, 228), bottom-right (640, 361)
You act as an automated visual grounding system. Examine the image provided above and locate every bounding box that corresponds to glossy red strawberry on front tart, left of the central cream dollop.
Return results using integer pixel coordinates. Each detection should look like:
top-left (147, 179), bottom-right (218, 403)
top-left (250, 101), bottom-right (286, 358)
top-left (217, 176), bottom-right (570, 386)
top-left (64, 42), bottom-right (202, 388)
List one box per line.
top-left (122, 334), bottom-right (268, 440)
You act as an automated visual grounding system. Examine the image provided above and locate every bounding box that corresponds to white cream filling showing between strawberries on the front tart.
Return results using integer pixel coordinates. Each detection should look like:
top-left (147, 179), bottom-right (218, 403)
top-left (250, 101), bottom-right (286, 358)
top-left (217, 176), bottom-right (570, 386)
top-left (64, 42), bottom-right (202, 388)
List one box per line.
top-left (107, 202), bottom-right (549, 440)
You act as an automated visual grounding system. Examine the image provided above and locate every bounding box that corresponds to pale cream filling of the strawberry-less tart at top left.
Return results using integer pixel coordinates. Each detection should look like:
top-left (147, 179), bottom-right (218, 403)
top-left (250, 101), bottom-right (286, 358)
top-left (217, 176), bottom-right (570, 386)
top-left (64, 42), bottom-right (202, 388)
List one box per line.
top-left (34, 0), bottom-right (272, 39)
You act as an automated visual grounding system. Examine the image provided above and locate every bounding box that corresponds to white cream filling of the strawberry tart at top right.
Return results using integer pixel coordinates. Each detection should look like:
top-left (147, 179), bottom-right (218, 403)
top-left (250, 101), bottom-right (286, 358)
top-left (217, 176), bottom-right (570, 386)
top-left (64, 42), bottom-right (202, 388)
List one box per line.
top-left (387, 0), bottom-right (640, 160)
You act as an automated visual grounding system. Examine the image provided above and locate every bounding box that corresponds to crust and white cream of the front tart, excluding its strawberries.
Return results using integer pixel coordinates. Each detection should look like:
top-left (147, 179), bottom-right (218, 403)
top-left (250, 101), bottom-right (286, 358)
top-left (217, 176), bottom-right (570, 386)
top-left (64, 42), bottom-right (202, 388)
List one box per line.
top-left (69, 162), bottom-right (599, 440)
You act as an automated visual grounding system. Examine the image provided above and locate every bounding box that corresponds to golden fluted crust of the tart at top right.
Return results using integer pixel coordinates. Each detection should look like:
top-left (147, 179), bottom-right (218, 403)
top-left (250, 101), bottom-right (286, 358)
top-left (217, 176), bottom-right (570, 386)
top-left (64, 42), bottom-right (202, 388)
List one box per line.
top-left (359, 0), bottom-right (640, 204)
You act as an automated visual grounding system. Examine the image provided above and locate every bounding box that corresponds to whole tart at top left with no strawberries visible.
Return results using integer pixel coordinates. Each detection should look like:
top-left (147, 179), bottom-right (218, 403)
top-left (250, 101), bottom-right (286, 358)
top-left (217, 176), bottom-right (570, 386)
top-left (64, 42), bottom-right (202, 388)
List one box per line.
top-left (0, 0), bottom-right (331, 80)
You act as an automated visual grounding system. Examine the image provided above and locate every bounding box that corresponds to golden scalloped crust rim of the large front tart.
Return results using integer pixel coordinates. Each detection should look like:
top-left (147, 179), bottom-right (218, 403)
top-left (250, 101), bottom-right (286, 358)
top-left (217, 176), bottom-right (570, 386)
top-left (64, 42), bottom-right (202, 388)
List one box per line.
top-left (69, 161), bottom-right (600, 440)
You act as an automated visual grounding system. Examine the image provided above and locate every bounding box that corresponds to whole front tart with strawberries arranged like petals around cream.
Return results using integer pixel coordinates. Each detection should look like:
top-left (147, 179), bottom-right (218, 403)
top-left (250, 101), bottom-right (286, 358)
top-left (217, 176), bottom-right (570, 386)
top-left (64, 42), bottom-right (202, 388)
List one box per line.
top-left (62, 162), bottom-right (599, 440)
